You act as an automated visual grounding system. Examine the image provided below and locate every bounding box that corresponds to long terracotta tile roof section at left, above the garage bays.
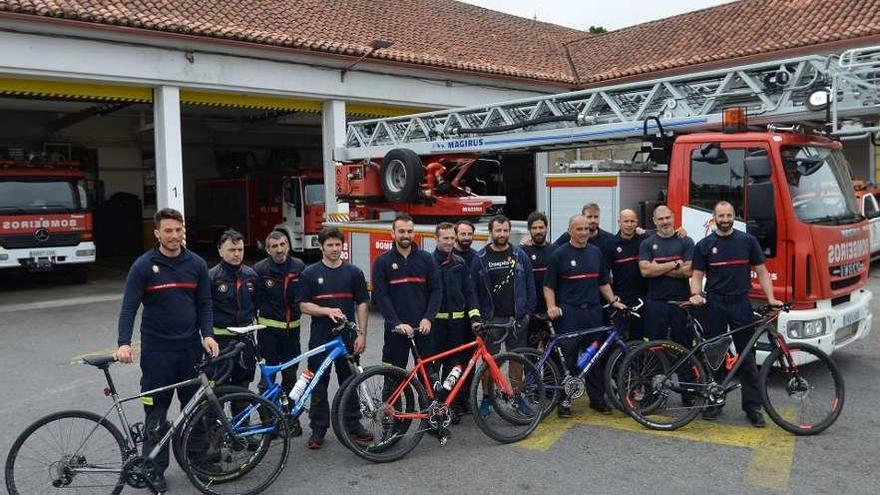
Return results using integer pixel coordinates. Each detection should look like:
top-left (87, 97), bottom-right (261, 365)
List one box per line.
top-left (0, 0), bottom-right (584, 83)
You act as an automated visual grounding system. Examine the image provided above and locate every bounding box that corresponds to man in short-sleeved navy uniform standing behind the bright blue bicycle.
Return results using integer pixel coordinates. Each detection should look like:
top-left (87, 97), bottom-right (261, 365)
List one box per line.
top-left (296, 227), bottom-right (373, 450)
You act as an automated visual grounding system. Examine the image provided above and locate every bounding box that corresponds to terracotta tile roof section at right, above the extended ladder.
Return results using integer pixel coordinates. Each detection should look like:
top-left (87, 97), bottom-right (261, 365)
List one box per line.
top-left (569, 0), bottom-right (880, 84)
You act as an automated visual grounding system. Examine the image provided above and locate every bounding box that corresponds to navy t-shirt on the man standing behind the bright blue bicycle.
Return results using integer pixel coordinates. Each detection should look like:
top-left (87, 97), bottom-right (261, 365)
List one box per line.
top-left (296, 261), bottom-right (370, 332)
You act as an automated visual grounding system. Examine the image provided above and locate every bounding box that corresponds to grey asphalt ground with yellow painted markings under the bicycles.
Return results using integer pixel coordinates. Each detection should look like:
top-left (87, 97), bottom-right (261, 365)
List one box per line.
top-left (0, 263), bottom-right (880, 495)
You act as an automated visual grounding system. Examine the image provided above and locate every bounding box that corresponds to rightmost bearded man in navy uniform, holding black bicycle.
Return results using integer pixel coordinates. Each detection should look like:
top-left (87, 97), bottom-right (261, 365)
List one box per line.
top-left (690, 201), bottom-right (782, 428)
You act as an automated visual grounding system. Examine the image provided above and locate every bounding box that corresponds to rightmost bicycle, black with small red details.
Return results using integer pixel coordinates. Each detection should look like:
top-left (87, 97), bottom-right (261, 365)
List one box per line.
top-left (618, 304), bottom-right (844, 435)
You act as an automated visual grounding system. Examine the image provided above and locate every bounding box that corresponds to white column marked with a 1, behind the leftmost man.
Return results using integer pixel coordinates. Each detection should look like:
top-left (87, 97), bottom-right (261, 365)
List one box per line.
top-left (153, 86), bottom-right (184, 213)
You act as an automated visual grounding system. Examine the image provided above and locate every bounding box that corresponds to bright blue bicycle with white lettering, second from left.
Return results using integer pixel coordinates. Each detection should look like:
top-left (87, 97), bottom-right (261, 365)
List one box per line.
top-left (215, 319), bottom-right (363, 448)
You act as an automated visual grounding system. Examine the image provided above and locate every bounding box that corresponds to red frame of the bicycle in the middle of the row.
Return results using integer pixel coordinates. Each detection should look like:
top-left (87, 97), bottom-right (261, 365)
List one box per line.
top-left (387, 336), bottom-right (513, 420)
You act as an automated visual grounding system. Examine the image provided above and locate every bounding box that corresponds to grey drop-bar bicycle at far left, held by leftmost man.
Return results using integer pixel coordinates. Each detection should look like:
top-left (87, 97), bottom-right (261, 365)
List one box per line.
top-left (6, 345), bottom-right (289, 495)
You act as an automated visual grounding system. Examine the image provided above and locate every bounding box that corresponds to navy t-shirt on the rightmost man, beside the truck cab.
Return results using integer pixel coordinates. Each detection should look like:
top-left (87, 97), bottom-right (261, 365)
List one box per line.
top-left (692, 230), bottom-right (764, 296)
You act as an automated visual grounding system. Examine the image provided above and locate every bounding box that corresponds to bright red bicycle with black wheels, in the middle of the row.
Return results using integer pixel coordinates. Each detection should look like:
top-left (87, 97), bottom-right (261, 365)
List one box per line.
top-left (334, 321), bottom-right (544, 462)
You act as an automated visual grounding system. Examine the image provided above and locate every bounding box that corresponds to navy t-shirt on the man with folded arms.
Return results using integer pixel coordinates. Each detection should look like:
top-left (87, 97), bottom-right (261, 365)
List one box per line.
top-left (639, 234), bottom-right (694, 301)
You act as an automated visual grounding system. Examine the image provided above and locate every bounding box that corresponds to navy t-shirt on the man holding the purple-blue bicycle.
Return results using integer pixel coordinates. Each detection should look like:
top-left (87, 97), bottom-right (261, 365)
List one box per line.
top-left (544, 243), bottom-right (608, 306)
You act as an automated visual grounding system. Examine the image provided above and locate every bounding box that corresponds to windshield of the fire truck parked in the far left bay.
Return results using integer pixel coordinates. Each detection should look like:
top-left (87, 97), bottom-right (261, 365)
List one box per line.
top-left (0, 178), bottom-right (86, 213)
